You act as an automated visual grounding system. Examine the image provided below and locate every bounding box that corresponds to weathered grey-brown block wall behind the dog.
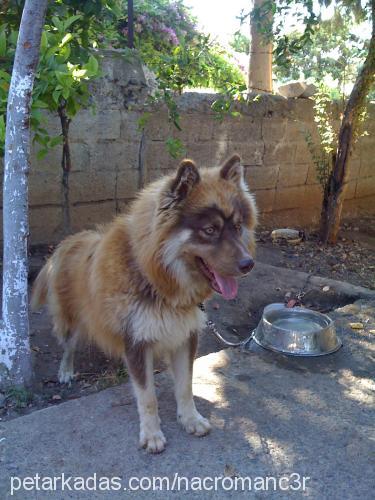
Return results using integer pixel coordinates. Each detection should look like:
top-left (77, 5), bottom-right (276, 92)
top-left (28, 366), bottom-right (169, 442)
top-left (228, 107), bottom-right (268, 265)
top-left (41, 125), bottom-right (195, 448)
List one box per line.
top-left (0, 54), bottom-right (375, 244)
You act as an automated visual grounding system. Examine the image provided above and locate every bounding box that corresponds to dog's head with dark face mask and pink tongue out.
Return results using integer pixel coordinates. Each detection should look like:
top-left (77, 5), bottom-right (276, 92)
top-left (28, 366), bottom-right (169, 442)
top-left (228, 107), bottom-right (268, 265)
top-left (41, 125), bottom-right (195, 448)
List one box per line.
top-left (160, 155), bottom-right (256, 299)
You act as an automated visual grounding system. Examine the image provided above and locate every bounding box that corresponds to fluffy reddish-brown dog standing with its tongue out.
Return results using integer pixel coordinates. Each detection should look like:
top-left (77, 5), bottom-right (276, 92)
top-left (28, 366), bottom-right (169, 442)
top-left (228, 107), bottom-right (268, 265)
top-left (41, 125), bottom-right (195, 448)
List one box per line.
top-left (31, 155), bottom-right (257, 453)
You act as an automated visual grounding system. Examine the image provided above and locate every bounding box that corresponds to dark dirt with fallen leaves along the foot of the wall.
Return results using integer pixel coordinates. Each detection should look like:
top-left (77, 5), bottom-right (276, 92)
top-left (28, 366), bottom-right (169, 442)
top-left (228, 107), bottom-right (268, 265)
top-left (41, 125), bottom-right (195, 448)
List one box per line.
top-left (0, 217), bottom-right (375, 420)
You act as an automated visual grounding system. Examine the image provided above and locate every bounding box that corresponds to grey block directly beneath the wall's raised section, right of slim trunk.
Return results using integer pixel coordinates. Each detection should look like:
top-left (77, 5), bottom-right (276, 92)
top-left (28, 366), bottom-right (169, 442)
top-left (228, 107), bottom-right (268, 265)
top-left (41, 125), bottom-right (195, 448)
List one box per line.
top-left (69, 109), bottom-right (121, 142)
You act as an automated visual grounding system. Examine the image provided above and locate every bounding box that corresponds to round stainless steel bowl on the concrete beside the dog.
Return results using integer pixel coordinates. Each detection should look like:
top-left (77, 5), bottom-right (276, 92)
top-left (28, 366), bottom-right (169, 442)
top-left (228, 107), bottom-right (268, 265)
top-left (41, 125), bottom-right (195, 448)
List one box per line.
top-left (253, 304), bottom-right (342, 356)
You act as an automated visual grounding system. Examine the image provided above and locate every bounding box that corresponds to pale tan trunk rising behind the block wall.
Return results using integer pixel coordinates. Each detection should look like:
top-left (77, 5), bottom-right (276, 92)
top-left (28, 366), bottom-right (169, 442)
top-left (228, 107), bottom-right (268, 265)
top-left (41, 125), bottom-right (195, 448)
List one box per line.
top-left (248, 0), bottom-right (273, 92)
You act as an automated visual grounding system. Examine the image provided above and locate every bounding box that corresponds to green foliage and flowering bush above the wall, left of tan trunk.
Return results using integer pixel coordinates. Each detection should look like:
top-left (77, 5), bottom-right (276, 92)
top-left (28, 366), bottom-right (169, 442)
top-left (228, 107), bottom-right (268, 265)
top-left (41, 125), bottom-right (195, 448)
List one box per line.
top-left (0, 0), bottom-right (244, 157)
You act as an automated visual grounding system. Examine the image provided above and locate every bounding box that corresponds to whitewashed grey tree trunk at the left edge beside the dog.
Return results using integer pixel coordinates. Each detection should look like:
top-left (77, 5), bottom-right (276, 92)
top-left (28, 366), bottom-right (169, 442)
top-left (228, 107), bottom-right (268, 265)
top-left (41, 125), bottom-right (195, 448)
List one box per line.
top-left (0, 0), bottom-right (48, 386)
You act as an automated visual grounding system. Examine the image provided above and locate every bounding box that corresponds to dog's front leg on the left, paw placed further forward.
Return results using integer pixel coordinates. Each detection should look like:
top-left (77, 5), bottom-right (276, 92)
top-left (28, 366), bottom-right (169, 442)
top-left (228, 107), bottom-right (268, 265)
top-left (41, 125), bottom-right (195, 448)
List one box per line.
top-left (125, 343), bottom-right (166, 453)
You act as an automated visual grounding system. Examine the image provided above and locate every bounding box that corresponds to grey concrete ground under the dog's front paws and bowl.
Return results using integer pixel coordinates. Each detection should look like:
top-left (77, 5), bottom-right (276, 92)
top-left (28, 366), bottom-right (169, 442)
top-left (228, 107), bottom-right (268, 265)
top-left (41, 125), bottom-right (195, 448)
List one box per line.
top-left (0, 266), bottom-right (375, 500)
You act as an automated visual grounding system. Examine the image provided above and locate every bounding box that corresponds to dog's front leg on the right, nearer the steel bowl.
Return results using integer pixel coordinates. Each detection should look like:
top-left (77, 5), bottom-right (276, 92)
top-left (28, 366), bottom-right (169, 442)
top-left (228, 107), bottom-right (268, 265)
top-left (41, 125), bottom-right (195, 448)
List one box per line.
top-left (171, 333), bottom-right (211, 436)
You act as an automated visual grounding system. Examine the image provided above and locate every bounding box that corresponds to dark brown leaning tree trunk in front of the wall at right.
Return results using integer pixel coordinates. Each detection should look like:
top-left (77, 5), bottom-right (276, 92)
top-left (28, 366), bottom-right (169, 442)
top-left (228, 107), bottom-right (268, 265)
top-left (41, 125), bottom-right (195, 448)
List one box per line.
top-left (320, 0), bottom-right (375, 244)
